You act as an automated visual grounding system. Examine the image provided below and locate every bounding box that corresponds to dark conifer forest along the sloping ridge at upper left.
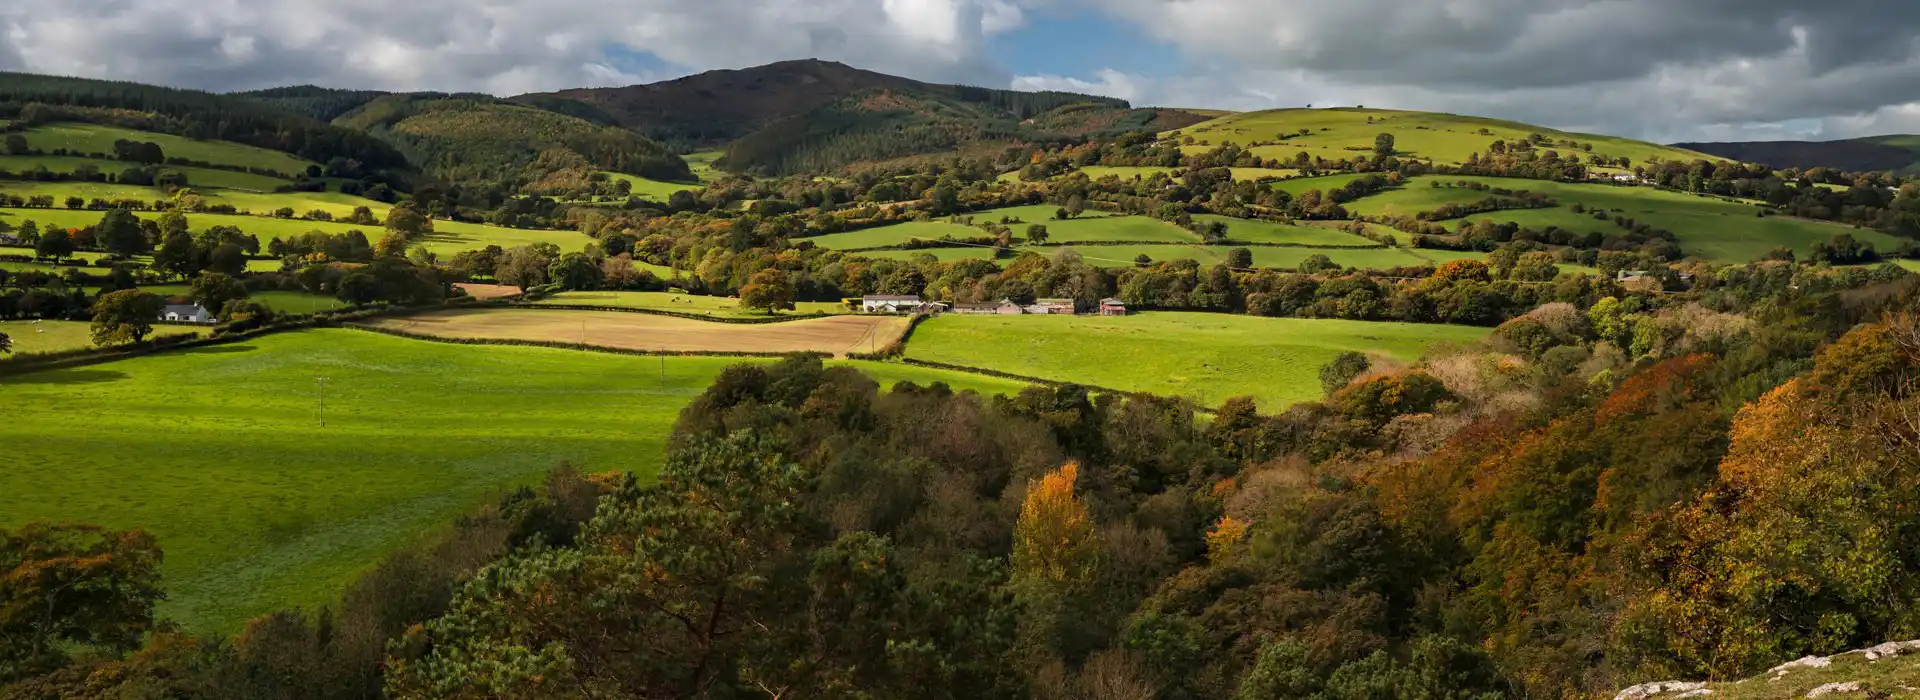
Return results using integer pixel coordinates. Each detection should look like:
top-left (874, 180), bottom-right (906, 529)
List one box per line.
top-left (0, 73), bottom-right (409, 173)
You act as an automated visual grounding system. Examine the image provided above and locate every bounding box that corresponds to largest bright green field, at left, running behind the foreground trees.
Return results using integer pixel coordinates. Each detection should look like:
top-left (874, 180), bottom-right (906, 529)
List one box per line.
top-left (0, 330), bottom-right (1020, 633)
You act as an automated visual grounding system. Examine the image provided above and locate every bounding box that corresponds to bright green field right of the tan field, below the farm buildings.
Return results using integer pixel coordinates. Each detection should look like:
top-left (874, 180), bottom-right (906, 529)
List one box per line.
top-left (906, 313), bottom-right (1488, 412)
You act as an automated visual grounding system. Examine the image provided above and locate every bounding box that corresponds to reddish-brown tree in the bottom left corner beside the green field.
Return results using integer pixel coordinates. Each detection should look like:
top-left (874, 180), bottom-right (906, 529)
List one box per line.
top-left (0, 524), bottom-right (165, 683)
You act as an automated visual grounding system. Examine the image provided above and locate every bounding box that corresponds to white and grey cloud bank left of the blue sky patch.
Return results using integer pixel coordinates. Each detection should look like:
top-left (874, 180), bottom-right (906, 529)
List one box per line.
top-left (0, 0), bottom-right (1023, 94)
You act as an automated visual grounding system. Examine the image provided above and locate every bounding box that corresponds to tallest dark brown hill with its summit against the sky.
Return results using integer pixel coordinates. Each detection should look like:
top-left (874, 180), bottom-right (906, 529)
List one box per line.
top-left (513, 59), bottom-right (1206, 175)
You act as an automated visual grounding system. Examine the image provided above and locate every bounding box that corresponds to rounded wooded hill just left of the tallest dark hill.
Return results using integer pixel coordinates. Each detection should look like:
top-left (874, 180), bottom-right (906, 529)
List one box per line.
top-left (334, 92), bottom-right (693, 182)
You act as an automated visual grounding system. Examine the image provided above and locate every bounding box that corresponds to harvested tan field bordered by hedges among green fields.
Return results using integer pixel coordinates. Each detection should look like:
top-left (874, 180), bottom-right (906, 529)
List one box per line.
top-left (367, 309), bottom-right (906, 355)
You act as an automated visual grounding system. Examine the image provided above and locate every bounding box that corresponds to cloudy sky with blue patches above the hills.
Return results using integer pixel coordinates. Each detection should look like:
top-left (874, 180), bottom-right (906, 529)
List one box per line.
top-left (0, 0), bottom-right (1920, 142)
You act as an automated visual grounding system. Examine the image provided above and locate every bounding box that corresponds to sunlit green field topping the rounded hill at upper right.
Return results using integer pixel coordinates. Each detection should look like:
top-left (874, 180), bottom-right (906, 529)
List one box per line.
top-left (1179, 107), bottom-right (1720, 165)
